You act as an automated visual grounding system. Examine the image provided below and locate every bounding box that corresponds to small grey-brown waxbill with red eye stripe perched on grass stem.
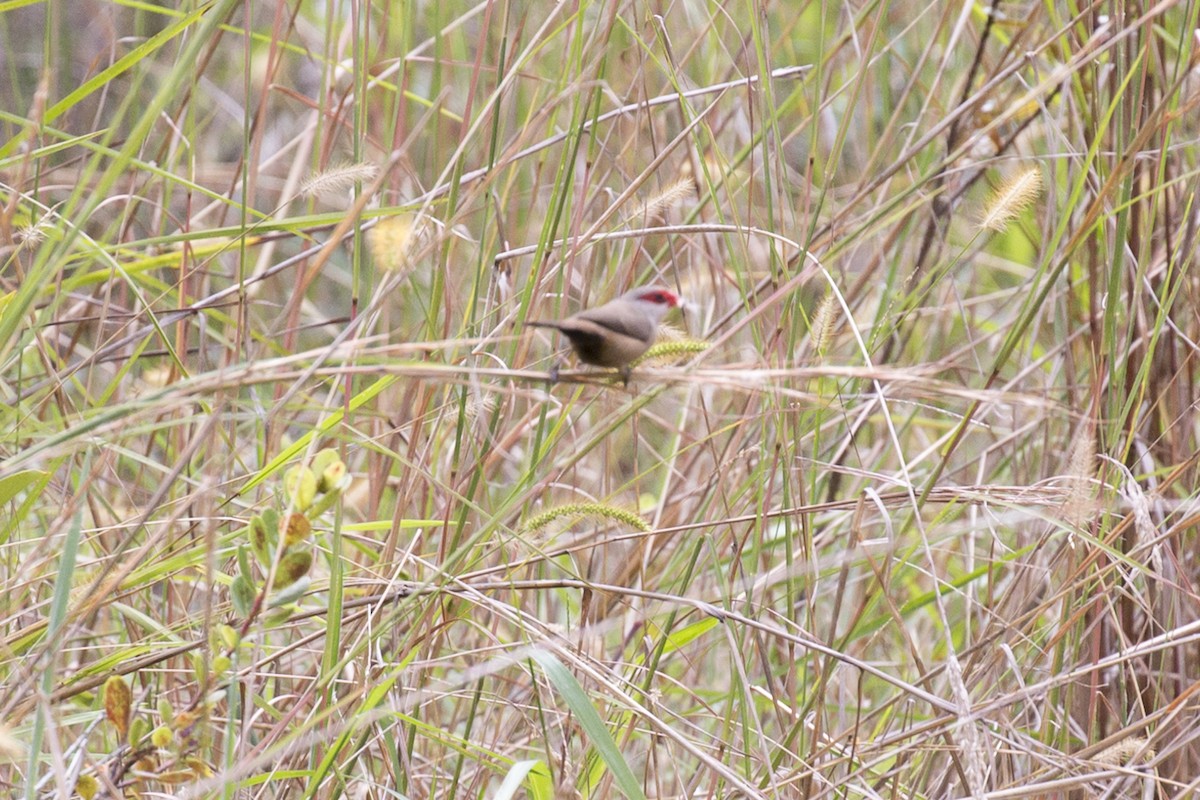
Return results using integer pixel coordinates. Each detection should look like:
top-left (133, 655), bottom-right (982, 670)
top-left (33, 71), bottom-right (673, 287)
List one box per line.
top-left (526, 287), bottom-right (684, 381)
